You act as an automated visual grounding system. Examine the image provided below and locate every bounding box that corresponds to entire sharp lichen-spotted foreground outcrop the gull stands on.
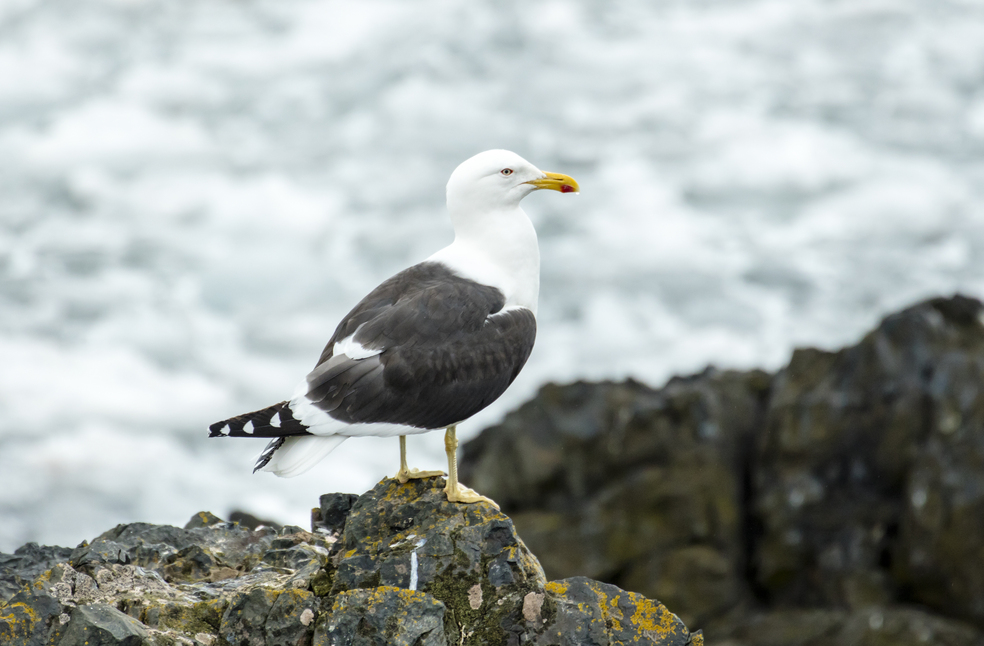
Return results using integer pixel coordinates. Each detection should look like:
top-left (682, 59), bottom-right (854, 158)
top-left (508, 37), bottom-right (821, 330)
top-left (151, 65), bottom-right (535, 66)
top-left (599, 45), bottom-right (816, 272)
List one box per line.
top-left (0, 478), bottom-right (703, 646)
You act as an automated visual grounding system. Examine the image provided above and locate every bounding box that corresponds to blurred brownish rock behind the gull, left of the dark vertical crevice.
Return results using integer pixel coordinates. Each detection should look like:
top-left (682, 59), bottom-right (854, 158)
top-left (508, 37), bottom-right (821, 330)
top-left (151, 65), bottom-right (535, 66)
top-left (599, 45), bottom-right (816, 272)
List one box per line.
top-left (460, 370), bottom-right (769, 623)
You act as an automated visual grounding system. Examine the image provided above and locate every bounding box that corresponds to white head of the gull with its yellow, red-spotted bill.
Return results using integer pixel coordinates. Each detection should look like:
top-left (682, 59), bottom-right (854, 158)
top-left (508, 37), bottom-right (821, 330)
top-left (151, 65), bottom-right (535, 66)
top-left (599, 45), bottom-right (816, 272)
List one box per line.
top-left (448, 150), bottom-right (580, 212)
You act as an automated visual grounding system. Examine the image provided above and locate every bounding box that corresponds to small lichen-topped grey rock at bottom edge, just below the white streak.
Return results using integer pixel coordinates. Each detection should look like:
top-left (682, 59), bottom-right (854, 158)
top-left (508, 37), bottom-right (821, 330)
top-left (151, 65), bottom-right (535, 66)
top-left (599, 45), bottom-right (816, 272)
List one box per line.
top-left (314, 586), bottom-right (448, 646)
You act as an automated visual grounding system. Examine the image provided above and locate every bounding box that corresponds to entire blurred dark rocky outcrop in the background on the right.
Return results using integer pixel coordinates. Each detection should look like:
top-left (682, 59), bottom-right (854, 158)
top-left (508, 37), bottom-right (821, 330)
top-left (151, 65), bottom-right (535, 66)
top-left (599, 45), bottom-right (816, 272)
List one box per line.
top-left (461, 296), bottom-right (984, 645)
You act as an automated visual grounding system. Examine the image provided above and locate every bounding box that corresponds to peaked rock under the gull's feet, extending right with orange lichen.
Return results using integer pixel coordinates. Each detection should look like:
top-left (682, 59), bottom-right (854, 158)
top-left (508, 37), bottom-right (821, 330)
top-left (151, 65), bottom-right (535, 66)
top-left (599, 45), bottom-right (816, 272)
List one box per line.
top-left (326, 478), bottom-right (691, 645)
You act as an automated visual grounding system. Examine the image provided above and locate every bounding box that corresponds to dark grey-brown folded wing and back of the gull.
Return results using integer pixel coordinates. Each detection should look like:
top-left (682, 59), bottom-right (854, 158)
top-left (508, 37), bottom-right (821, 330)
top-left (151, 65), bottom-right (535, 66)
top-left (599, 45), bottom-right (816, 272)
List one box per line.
top-left (306, 263), bottom-right (536, 428)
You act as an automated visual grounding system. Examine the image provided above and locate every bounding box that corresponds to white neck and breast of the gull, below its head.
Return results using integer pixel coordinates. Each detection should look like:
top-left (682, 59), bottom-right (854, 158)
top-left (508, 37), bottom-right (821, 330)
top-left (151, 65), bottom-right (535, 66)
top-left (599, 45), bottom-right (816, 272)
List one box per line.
top-left (427, 205), bottom-right (540, 314)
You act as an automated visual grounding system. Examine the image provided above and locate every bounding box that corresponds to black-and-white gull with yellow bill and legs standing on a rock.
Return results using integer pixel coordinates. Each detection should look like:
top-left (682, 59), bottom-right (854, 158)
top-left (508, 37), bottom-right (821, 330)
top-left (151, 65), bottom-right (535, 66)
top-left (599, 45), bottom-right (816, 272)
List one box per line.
top-left (209, 150), bottom-right (580, 508)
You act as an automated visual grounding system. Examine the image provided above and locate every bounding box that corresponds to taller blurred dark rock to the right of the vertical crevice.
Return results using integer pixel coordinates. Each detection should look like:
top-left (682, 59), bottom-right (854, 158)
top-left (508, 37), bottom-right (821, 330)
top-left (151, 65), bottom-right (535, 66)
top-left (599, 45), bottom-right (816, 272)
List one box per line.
top-left (754, 297), bottom-right (984, 625)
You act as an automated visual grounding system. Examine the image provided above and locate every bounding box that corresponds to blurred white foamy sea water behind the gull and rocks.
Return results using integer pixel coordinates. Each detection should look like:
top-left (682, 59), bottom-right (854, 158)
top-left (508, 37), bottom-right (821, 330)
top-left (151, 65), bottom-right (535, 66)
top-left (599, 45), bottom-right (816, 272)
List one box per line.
top-left (0, 0), bottom-right (984, 551)
